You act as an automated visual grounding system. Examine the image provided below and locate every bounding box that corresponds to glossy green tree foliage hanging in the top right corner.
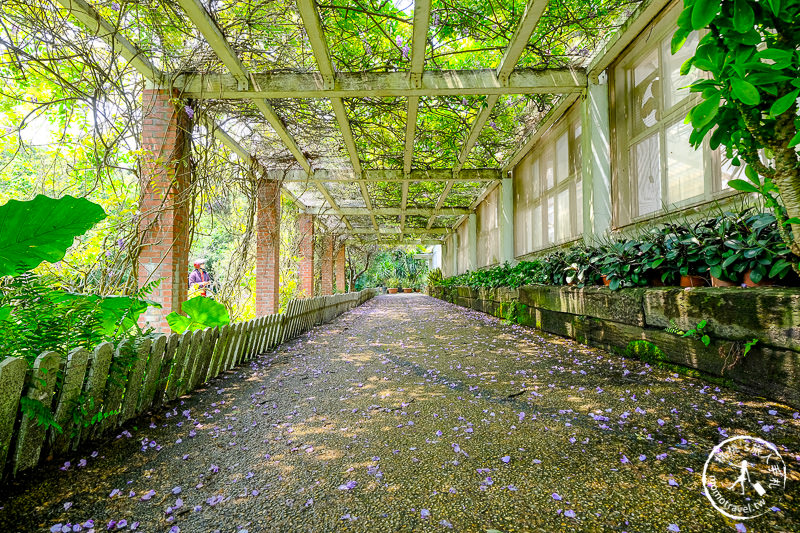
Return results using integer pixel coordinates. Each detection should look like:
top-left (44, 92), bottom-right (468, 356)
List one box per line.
top-left (672, 0), bottom-right (800, 254)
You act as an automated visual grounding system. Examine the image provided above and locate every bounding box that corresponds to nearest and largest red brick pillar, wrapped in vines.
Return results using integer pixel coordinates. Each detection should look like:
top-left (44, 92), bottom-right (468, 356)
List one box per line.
top-left (138, 89), bottom-right (191, 332)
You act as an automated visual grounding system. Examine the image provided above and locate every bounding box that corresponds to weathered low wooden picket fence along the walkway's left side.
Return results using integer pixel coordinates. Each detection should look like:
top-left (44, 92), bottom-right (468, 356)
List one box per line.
top-left (0, 289), bottom-right (375, 476)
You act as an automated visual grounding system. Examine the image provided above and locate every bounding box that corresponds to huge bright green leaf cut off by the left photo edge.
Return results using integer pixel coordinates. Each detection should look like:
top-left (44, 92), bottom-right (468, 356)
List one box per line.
top-left (0, 194), bottom-right (106, 276)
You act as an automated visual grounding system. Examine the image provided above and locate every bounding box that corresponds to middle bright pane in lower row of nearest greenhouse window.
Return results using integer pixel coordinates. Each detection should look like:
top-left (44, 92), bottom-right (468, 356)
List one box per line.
top-left (667, 121), bottom-right (705, 203)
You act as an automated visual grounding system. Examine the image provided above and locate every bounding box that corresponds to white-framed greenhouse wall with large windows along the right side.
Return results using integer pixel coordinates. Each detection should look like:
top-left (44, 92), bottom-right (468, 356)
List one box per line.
top-left (456, 2), bottom-right (749, 268)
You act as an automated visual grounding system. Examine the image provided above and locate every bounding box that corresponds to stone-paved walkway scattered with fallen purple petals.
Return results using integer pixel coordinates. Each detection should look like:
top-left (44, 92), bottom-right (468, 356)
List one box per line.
top-left (0, 295), bottom-right (800, 533)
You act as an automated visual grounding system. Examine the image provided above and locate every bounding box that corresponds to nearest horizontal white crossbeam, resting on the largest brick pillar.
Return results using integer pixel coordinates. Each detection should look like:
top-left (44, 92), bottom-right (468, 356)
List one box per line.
top-left (178, 67), bottom-right (586, 100)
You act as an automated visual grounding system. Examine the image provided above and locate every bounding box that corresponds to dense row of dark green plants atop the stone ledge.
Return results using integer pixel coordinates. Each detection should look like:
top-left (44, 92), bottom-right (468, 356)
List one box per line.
top-left (429, 209), bottom-right (798, 290)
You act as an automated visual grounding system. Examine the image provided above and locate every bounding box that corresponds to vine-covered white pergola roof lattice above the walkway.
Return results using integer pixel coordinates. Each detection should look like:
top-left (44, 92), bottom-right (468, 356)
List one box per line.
top-left (57, 0), bottom-right (665, 243)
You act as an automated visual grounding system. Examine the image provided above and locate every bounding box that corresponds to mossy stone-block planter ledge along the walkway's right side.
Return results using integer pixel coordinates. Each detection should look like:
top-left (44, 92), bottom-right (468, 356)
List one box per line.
top-left (430, 285), bottom-right (800, 407)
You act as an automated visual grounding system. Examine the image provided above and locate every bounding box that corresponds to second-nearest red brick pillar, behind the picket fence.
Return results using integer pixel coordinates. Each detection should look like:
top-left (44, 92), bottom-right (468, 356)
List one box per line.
top-left (256, 180), bottom-right (281, 316)
